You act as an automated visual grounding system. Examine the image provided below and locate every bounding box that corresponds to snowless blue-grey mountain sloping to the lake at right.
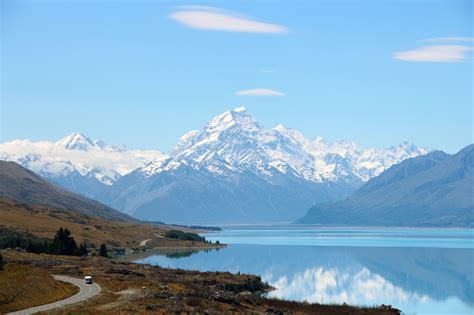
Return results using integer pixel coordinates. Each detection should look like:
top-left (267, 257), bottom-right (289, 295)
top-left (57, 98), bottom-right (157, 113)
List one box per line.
top-left (298, 144), bottom-right (474, 227)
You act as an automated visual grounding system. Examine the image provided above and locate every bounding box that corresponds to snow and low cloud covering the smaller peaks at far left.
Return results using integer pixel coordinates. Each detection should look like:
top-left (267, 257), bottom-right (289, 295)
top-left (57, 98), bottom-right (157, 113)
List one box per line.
top-left (0, 133), bottom-right (167, 185)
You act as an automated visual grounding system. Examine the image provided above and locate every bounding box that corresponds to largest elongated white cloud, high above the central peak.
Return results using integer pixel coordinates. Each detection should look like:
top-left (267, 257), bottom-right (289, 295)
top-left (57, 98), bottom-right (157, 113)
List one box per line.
top-left (170, 6), bottom-right (288, 34)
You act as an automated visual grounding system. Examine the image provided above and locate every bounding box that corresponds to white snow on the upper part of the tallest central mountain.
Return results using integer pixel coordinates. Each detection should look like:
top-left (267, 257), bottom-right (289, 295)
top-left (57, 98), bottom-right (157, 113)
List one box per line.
top-left (142, 107), bottom-right (429, 183)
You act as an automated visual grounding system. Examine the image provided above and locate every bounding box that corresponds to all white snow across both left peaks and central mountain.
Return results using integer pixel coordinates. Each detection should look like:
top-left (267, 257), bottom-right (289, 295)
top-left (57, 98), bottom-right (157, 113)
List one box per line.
top-left (0, 107), bottom-right (429, 190)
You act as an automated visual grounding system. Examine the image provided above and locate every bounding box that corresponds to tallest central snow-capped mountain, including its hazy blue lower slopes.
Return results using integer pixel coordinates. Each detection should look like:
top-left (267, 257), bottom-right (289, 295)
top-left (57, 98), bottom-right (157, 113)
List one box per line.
top-left (99, 107), bottom-right (429, 224)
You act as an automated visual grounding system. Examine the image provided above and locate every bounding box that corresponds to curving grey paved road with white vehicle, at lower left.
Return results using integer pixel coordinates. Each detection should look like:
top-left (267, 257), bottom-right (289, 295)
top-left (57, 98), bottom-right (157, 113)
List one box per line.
top-left (8, 275), bottom-right (100, 315)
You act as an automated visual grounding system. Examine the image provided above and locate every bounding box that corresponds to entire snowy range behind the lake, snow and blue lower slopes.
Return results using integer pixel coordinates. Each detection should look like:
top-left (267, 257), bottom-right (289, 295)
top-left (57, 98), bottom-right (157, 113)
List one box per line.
top-left (0, 107), bottom-right (430, 224)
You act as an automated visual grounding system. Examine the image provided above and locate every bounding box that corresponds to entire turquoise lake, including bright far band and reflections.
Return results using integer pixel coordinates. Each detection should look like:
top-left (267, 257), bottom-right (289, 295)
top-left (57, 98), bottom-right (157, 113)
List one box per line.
top-left (131, 226), bottom-right (474, 314)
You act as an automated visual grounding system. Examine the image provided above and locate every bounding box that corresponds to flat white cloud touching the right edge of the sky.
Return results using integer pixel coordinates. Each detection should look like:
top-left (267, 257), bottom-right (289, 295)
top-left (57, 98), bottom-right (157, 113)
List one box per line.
top-left (393, 45), bottom-right (472, 62)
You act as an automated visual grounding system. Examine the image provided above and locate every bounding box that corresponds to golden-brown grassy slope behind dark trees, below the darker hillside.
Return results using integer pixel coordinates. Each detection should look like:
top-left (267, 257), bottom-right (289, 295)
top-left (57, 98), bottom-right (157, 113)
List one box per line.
top-left (0, 198), bottom-right (217, 248)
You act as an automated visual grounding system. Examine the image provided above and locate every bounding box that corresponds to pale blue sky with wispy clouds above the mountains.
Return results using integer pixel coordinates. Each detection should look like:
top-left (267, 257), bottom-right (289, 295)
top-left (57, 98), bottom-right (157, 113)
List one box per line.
top-left (0, 0), bottom-right (474, 153)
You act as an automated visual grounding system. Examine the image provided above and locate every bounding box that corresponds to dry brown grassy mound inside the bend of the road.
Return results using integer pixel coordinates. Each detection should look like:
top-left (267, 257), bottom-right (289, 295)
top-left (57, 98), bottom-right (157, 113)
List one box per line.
top-left (0, 264), bottom-right (79, 313)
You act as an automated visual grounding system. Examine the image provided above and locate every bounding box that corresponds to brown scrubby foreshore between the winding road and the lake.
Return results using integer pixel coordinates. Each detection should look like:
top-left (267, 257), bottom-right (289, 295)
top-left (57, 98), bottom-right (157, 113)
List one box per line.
top-left (0, 250), bottom-right (400, 315)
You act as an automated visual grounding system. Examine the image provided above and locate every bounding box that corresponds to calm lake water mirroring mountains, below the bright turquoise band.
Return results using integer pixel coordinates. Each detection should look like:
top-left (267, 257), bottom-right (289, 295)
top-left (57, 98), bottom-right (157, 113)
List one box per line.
top-left (132, 230), bottom-right (474, 314)
